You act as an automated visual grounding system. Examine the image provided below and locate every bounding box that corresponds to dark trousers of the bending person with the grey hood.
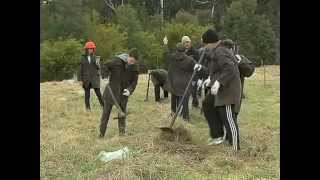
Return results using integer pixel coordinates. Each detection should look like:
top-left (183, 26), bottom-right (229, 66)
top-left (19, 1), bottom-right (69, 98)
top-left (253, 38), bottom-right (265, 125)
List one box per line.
top-left (100, 95), bottom-right (128, 136)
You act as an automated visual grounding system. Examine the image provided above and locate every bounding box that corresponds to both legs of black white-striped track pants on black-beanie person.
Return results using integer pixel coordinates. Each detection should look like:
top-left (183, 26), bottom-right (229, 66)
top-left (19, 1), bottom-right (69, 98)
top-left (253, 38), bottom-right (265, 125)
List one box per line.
top-left (203, 94), bottom-right (240, 150)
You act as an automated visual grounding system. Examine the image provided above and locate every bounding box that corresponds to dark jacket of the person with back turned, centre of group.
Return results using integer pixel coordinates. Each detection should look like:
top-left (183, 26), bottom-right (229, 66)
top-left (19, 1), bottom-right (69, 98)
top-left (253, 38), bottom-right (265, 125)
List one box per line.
top-left (164, 52), bottom-right (196, 96)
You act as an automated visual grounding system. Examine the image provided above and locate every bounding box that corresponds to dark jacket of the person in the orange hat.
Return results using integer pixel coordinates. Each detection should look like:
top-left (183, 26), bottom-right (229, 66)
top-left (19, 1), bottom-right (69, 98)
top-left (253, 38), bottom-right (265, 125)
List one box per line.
top-left (78, 55), bottom-right (100, 88)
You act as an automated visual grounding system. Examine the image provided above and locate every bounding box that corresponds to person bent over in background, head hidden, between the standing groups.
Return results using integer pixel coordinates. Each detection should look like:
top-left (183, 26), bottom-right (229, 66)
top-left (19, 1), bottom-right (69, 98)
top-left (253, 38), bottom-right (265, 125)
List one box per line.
top-left (150, 69), bottom-right (168, 102)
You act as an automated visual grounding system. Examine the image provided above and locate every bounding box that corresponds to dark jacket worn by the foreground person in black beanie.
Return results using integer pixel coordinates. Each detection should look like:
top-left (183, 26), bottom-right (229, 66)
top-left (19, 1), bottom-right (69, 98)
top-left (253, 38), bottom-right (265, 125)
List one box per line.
top-left (208, 46), bottom-right (241, 106)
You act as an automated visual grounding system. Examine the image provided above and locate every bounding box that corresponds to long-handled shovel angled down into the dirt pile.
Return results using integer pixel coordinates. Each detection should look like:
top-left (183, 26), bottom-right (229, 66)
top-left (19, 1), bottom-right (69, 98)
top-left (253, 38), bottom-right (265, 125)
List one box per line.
top-left (159, 49), bottom-right (205, 133)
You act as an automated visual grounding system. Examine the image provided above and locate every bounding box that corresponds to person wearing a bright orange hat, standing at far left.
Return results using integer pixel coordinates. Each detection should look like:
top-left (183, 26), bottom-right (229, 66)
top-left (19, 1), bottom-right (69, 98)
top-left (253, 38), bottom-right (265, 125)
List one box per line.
top-left (79, 41), bottom-right (103, 111)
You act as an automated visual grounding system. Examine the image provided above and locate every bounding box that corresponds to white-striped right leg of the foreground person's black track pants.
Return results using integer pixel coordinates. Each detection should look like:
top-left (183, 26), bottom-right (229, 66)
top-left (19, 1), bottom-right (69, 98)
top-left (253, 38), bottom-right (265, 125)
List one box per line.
top-left (216, 105), bottom-right (240, 150)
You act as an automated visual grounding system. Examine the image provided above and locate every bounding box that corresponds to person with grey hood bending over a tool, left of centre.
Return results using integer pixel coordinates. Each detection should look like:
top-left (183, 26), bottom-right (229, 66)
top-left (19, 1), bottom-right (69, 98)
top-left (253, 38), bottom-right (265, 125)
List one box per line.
top-left (100, 48), bottom-right (138, 138)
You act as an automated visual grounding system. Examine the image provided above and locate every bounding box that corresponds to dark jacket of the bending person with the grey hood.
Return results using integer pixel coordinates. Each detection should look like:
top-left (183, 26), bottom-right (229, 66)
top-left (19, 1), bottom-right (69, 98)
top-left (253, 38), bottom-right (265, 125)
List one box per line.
top-left (103, 57), bottom-right (138, 104)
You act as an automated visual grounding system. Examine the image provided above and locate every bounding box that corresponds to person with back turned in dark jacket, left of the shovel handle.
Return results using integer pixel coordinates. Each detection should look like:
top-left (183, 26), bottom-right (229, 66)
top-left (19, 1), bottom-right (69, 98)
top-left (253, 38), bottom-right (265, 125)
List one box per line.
top-left (165, 43), bottom-right (201, 121)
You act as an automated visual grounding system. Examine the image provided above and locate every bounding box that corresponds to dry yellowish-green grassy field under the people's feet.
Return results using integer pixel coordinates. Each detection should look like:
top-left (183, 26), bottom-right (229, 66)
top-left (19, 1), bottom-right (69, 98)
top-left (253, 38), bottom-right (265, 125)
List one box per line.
top-left (40, 66), bottom-right (280, 180)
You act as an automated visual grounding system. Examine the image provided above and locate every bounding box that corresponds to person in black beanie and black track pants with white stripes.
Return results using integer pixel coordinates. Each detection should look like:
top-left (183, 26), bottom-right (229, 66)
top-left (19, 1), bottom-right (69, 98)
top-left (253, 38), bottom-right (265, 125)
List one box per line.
top-left (202, 29), bottom-right (241, 151)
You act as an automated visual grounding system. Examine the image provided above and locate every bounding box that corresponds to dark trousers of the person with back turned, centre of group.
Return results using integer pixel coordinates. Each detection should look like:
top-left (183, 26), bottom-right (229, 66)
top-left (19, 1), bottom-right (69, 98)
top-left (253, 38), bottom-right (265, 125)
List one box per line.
top-left (171, 94), bottom-right (190, 121)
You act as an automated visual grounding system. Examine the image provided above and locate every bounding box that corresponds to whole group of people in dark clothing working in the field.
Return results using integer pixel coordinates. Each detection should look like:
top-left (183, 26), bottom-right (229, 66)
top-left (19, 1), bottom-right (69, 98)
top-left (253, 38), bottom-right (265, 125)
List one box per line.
top-left (80, 29), bottom-right (255, 151)
